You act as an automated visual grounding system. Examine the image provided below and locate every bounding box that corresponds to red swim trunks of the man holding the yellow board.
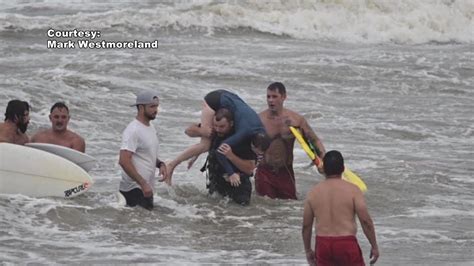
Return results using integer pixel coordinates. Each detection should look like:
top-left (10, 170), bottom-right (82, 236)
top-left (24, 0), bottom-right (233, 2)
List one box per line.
top-left (255, 165), bottom-right (296, 199)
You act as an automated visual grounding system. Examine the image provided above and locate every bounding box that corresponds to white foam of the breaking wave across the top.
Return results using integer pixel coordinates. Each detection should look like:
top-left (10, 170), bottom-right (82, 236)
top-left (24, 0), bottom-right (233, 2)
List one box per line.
top-left (0, 0), bottom-right (474, 43)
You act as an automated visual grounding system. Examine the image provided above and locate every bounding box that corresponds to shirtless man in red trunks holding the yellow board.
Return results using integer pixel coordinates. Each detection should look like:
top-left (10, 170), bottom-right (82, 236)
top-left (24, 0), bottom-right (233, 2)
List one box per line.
top-left (255, 82), bottom-right (325, 199)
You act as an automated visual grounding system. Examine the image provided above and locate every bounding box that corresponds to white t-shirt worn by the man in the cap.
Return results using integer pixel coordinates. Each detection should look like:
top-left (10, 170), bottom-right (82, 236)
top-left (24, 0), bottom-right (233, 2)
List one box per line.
top-left (119, 119), bottom-right (158, 192)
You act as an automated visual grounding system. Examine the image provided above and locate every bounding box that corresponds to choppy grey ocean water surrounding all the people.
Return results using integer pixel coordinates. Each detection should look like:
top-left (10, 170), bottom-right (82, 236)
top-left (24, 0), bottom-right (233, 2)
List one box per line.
top-left (0, 0), bottom-right (474, 265)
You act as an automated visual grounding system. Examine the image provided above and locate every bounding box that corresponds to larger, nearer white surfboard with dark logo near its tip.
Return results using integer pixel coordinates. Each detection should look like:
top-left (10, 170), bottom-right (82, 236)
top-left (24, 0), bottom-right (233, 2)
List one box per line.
top-left (0, 143), bottom-right (93, 198)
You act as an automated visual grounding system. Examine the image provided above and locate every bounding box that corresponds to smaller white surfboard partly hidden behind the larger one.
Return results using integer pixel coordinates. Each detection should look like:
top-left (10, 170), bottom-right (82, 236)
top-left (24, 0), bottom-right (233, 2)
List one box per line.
top-left (26, 143), bottom-right (96, 172)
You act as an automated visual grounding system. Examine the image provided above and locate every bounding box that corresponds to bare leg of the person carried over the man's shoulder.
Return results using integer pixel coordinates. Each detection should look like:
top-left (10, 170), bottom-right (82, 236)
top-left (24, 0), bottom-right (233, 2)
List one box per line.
top-left (166, 101), bottom-right (215, 185)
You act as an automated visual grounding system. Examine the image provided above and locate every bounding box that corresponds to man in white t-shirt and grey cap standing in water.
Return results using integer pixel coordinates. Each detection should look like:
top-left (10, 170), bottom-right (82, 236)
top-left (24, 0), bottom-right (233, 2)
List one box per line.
top-left (119, 91), bottom-right (169, 210)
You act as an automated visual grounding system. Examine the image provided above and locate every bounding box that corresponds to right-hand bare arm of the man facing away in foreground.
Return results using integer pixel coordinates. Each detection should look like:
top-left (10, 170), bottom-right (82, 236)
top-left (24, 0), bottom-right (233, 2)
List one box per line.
top-left (354, 189), bottom-right (379, 264)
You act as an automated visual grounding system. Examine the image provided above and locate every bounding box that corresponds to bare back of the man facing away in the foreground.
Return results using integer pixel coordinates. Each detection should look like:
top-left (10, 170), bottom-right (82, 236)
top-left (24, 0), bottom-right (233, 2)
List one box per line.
top-left (308, 178), bottom-right (362, 236)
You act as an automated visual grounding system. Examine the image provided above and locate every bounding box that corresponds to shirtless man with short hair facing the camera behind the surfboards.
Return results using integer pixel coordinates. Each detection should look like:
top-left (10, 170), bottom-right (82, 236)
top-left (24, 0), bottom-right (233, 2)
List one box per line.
top-left (31, 102), bottom-right (86, 152)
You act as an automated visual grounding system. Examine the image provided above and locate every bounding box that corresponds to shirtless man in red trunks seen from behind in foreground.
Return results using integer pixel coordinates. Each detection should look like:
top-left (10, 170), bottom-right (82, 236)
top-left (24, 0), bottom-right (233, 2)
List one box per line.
top-left (302, 151), bottom-right (379, 265)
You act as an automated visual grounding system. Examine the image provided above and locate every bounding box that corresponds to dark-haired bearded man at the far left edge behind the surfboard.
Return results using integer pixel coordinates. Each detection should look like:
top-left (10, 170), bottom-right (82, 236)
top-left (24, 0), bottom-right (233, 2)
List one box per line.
top-left (0, 100), bottom-right (30, 145)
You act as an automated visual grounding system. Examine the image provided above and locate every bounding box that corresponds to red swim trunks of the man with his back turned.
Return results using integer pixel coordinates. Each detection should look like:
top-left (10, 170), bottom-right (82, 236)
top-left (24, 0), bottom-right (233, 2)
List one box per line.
top-left (315, 236), bottom-right (365, 266)
